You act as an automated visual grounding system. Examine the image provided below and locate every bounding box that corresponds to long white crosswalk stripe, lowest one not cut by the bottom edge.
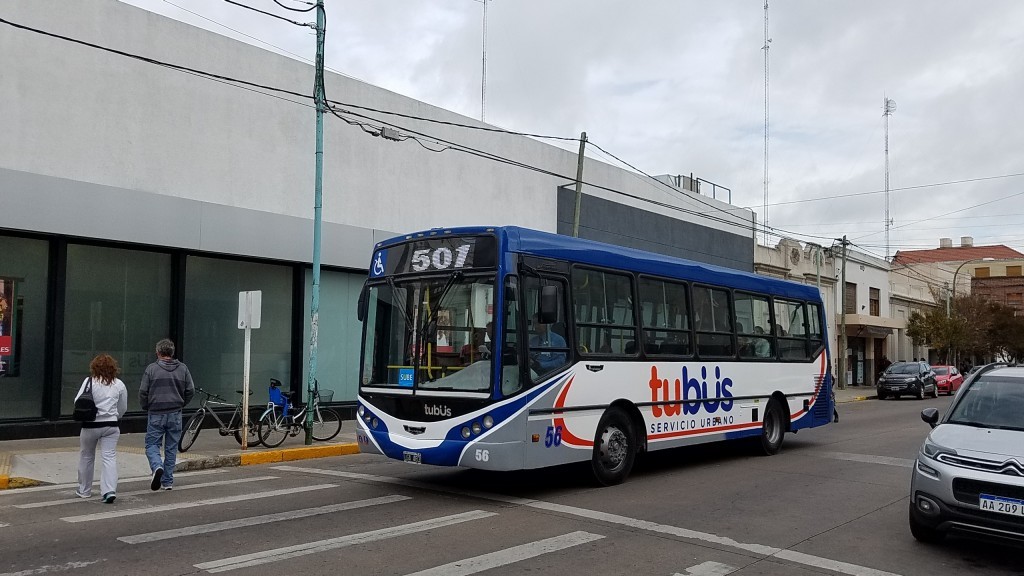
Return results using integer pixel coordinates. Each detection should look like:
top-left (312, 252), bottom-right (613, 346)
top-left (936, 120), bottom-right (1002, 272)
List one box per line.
top-left (195, 510), bottom-right (498, 572)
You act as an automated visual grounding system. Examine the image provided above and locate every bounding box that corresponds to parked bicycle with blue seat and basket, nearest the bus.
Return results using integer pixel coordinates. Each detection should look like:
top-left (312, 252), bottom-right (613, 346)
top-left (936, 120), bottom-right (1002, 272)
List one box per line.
top-left (259, 378), bottom-right (341, 448)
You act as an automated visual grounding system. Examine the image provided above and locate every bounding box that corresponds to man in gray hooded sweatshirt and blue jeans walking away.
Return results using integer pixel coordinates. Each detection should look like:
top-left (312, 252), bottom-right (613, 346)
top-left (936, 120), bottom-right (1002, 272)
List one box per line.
top-left (138, 338), bottom-right (196, 490)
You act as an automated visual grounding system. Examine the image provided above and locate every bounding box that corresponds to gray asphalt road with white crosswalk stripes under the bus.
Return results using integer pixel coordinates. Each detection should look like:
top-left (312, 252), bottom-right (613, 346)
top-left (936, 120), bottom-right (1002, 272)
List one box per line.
top-left (0, 398), bottom-right (1024, 576)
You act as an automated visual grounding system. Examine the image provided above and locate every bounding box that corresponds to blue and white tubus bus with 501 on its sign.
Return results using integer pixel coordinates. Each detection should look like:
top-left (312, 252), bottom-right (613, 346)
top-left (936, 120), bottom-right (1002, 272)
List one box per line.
top-left (357, 227), bottom-right (834, 485)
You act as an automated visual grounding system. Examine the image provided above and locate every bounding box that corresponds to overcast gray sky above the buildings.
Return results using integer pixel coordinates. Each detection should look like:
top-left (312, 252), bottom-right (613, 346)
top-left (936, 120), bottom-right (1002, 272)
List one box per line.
top-left (124, 0), bottom-right (1024, 256)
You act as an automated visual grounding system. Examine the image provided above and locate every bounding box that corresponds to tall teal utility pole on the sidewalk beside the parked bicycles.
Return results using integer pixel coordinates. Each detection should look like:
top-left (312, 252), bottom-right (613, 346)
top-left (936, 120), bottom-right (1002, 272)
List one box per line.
top-left (305, 0), bottom-right (327, 446)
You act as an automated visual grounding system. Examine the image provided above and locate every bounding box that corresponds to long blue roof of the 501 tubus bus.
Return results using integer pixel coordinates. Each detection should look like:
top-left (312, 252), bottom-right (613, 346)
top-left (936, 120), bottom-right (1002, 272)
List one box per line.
top-left (377, 227), bottom-right (821, 300)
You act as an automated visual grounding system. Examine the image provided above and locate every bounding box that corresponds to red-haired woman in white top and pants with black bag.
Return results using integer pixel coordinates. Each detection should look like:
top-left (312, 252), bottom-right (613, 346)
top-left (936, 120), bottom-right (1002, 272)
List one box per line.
top-left (75, 354), bottom-right (128, 504)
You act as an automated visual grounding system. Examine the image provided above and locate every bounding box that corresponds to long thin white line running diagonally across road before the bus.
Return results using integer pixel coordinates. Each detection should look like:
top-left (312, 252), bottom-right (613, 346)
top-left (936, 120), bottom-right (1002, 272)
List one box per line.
top-left (271, 466), bottom-right (900, 576)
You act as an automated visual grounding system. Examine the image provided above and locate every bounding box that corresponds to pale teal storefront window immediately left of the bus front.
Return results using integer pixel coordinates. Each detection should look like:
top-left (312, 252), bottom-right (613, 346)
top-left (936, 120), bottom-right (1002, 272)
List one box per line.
top-left (302, 271), bottom-right (366, 402)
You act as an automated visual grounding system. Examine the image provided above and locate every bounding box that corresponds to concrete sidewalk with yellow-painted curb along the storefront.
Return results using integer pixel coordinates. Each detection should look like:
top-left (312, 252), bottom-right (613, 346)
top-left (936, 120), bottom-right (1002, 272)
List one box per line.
top-left (0, 420), bottom-right (359, 490)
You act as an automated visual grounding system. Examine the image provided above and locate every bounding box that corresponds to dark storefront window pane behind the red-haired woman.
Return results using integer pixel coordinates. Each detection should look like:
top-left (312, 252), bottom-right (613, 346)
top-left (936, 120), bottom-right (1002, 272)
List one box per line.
top-left (60, 244), bottom-right (171, 414)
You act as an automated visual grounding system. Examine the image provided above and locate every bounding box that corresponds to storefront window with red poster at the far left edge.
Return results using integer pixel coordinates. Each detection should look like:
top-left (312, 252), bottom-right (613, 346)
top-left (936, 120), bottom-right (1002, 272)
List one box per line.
top-left (0, 236), bottom-right (49, 418)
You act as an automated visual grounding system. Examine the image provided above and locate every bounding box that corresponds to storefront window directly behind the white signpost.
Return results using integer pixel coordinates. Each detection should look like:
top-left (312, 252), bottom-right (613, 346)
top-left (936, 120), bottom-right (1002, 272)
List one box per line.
top-left (186, 256), bottom-right (292, 404)
